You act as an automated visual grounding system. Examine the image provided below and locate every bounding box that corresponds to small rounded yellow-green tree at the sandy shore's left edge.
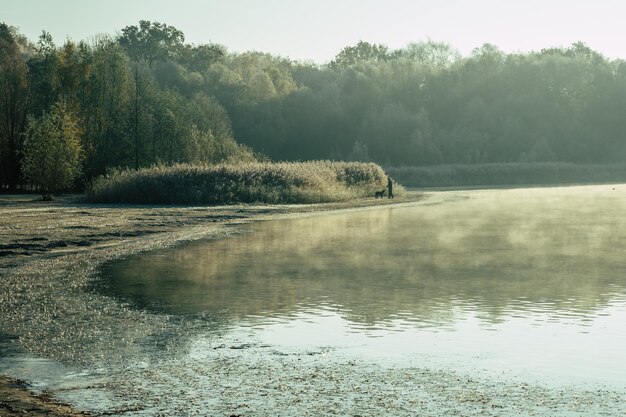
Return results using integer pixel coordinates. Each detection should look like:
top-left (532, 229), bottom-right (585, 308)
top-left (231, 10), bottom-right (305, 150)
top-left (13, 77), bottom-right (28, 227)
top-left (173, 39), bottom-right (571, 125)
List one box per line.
top-left (22, 101), bottom-right (82, 200)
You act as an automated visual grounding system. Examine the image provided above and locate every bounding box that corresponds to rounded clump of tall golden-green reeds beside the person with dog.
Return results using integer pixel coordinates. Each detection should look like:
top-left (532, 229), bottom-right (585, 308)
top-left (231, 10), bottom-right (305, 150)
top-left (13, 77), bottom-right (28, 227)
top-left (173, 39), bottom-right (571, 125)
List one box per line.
top-left (87, 161), bottom-right (402, 204)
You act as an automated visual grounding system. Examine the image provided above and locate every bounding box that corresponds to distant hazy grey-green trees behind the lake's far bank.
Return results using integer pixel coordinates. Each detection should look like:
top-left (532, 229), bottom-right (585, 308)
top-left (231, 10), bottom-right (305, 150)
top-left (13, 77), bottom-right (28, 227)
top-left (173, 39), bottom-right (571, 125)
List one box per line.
top-left (232, 42), bottom-right (626, 166)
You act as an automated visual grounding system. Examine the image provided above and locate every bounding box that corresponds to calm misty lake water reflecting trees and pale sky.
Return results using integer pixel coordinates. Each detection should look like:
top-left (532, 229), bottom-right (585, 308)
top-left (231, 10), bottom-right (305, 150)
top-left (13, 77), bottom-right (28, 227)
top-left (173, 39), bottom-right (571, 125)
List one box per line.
top-left (104, 186), bottom-right (626, 387)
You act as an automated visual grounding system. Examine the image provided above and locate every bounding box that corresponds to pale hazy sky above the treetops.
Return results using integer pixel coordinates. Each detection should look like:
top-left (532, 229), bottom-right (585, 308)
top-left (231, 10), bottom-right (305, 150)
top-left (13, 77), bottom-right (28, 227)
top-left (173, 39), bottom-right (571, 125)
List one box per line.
top-left (0, 0), bottom-right (626, 63)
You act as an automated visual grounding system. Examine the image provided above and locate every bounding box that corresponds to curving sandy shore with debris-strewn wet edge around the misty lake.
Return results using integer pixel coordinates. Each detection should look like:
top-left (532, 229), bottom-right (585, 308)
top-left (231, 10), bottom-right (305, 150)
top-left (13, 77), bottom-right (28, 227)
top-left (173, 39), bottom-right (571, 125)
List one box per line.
top-left (0, 193), bottom-right (626, 417)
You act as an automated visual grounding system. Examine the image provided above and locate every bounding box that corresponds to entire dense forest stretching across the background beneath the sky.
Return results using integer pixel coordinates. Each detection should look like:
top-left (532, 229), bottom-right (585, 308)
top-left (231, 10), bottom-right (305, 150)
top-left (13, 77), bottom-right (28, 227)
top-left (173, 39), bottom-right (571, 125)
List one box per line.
top-left (0, 21), bottom-right (626, 190)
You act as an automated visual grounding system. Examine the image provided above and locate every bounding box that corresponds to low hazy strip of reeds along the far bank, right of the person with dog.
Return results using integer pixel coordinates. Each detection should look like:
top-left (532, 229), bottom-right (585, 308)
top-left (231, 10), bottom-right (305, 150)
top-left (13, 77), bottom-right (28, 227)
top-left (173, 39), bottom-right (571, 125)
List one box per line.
top-left (386, 162), bottom-right (626, 187)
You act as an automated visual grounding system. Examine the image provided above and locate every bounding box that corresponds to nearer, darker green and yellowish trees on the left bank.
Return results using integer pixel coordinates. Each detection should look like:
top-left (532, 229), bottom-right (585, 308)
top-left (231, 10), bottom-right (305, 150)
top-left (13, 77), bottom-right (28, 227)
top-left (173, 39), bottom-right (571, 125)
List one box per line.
top-left (0, 21), bottom-right (255, 191)
